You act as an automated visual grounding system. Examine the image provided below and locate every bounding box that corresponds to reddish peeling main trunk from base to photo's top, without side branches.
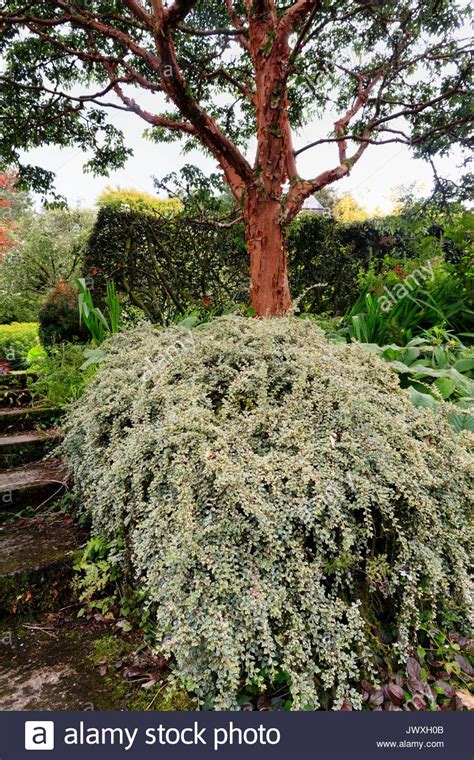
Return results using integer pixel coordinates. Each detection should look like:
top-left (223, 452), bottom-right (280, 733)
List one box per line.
top-left (244, 0), bottom-right (297, 317)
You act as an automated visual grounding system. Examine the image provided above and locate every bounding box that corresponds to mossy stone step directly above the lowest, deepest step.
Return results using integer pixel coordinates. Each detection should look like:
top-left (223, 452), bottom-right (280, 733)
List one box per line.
top-left (0, 459), bottom-right (68, 513)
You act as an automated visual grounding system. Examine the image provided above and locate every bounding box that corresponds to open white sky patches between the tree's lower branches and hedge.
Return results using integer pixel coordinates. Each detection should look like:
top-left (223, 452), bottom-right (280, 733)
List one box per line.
top-left (21, 91), bottom-right (460, 212)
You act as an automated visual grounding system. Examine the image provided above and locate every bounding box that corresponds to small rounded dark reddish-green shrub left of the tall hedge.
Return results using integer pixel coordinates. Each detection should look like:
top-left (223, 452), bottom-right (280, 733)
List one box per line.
top-left (38, 280), bottom-right (89, 349)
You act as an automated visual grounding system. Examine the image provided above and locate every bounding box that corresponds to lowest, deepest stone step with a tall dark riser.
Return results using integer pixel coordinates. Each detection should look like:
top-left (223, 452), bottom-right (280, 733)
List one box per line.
top-left (0, 515), bottom-right (80, 618)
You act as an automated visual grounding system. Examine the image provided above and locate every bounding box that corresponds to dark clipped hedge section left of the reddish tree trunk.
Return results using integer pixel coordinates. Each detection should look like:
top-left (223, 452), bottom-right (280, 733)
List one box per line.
top-left (84, 206), bottom-right (248, 322)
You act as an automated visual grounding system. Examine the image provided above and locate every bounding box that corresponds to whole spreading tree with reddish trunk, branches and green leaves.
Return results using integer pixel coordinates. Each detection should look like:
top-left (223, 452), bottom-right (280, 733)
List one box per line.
top-left (0, 0), bottom-right (473, 313)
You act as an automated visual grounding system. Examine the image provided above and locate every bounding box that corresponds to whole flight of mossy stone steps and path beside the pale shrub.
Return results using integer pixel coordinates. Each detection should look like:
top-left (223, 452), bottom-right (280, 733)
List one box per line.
top-left (0, 372), bottom-right (116, 710)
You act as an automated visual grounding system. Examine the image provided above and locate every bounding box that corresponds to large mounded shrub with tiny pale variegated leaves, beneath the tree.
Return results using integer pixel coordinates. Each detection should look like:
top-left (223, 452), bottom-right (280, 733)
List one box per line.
top-left (64, 317), bottom-right (472, 709)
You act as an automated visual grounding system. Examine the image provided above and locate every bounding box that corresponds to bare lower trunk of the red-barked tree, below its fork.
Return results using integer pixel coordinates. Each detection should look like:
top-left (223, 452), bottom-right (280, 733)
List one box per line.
top-left (245, 193), bottom-right (291, 317)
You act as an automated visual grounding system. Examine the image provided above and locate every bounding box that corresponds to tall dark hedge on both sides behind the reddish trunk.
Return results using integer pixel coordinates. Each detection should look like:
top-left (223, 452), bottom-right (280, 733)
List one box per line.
top-left (84, 206), bottom-right (459, 322)
